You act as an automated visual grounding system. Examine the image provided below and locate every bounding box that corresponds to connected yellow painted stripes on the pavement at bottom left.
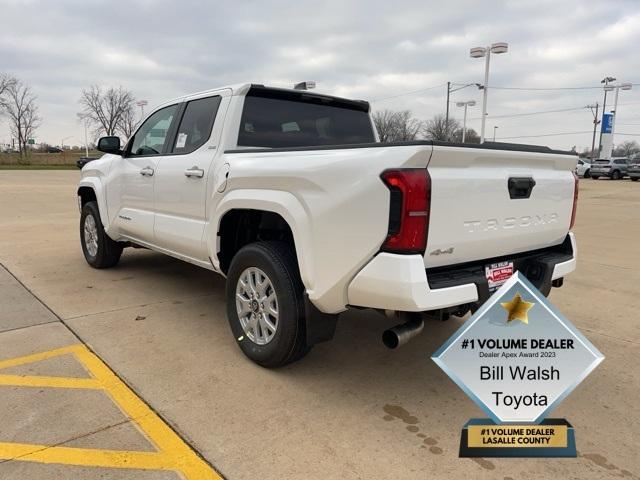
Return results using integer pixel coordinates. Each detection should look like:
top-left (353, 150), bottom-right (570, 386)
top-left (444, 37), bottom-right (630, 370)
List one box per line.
top-left (0, 345), bottom-right (221, 480)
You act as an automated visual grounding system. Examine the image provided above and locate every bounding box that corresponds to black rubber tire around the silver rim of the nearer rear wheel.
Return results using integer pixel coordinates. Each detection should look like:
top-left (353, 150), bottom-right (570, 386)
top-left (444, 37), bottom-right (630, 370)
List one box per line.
top-left (226, 242), bottom-right (311, 368)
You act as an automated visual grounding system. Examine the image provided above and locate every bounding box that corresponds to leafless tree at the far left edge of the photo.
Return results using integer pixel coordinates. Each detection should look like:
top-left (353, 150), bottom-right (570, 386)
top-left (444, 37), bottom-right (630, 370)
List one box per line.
top-left (0, 79), bottom-right (41, 156)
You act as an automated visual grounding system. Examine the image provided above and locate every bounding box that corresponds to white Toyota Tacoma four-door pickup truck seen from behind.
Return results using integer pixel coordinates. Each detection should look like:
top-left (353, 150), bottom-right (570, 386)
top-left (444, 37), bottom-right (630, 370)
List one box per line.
top-left (77, 84), bottom-right (578, 367)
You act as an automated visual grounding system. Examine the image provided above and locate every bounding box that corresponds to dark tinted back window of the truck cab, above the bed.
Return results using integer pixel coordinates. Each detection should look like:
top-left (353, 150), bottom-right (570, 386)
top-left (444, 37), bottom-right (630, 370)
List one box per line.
top-left (238, 88), bottom-right (375, 148)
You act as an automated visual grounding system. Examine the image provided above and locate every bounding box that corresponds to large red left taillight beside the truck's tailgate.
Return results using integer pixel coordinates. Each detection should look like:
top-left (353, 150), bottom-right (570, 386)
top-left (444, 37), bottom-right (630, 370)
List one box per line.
top-left (381, 168), bottom-right (431, 253)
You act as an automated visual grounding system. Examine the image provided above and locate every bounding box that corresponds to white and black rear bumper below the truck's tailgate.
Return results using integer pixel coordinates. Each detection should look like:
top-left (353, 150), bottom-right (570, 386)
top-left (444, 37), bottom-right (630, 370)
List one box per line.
top-left (348, 233), bottom-right (577, 312)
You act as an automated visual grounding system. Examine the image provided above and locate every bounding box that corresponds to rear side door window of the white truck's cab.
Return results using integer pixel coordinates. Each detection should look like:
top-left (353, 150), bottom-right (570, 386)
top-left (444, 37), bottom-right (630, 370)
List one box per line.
top-left (172, 97), bottom-right (220, 153)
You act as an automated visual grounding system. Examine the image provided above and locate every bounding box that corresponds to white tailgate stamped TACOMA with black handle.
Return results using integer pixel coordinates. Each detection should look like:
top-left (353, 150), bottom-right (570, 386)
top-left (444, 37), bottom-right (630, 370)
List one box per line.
top-left (424, 146), bottom-right (577, 267)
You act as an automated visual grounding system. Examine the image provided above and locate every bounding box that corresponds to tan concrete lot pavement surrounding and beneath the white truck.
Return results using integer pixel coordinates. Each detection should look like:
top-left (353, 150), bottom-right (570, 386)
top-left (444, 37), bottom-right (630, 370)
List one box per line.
top-left (0, 171), bottom-right (640, 479)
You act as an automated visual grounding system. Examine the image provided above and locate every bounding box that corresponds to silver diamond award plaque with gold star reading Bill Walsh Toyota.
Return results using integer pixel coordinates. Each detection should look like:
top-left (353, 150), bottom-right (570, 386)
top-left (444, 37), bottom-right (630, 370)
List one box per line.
top-left (432, 272), bottom-right (604, 453)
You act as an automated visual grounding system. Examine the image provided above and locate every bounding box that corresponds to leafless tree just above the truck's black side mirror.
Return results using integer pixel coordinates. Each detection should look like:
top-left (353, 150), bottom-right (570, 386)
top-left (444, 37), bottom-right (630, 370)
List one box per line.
top-left (78, 85), bottom-right (135, 135)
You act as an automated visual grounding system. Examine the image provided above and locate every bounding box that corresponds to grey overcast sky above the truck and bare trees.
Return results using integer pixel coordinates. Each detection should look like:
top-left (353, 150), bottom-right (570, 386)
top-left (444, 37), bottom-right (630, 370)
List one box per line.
top-left (0, 0), bottom-right (640, 149)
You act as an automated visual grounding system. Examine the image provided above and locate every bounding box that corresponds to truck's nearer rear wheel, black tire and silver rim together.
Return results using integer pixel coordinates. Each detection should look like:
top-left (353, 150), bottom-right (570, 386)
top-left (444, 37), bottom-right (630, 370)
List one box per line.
top-left (226, 242), bottom-right (310, 368)
